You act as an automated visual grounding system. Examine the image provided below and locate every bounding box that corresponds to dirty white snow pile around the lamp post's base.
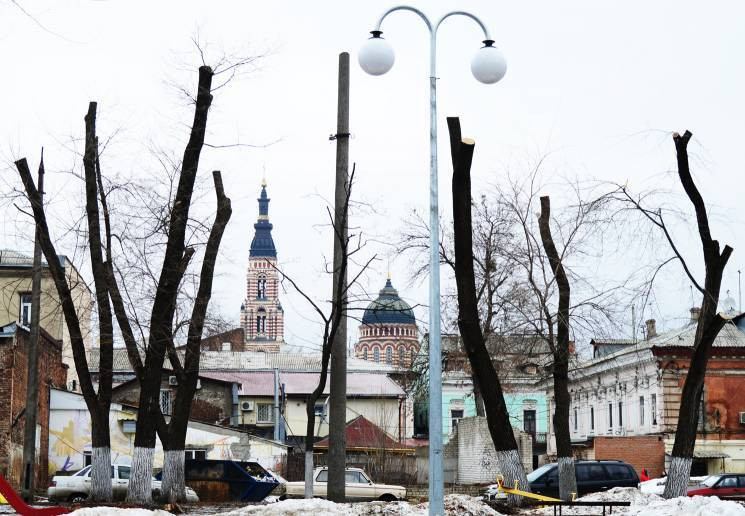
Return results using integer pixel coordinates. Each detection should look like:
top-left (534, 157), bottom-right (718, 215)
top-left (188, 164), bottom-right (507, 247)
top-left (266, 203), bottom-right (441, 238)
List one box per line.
top-left (221, 495), bottom-right (500, 516)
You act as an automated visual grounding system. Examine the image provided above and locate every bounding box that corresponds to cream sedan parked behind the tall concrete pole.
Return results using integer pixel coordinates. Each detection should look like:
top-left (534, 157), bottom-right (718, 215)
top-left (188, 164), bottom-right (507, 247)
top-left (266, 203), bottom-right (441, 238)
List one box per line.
top-left (280, 468), bottom-right (406, 502)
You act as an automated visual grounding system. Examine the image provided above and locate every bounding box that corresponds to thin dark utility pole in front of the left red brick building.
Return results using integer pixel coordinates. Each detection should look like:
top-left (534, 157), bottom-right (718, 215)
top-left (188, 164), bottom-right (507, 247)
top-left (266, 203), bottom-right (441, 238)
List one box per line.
top-left (21, 155), bottom-right (44, 502)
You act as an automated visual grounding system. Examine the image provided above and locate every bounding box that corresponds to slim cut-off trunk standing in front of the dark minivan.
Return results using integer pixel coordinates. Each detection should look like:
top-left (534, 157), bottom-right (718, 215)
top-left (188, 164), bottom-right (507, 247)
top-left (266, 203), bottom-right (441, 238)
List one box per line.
top-left (538, 196), bottom-right (577, 500)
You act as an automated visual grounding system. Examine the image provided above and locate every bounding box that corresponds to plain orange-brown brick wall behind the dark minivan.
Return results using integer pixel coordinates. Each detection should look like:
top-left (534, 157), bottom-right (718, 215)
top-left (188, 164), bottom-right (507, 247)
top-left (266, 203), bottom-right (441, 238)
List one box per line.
top-left (594, 435), bottom-right (665, 478)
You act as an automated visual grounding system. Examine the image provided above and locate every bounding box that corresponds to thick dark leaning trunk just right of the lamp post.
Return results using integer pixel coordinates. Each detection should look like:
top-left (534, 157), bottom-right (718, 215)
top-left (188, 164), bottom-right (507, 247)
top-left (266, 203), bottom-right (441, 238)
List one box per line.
top-left (447, 117), bottom-right (530, 505)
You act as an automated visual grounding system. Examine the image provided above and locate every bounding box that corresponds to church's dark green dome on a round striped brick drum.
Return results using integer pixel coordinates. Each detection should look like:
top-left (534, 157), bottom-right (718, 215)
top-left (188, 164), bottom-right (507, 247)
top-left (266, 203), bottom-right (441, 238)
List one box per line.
top-left (354, 277), bottom-right (419, 368)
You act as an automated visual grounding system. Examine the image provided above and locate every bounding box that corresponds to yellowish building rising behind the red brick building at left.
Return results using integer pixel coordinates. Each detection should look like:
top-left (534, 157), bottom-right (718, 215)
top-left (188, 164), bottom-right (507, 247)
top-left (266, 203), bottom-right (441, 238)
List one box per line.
top-left (0, 249), bottom-right (93, 391)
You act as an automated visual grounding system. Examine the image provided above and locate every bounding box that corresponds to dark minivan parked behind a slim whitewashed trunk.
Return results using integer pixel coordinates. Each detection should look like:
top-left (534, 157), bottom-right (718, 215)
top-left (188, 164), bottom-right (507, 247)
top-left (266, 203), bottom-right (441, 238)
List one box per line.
top-left (528, 460), bottom-right (639, 498)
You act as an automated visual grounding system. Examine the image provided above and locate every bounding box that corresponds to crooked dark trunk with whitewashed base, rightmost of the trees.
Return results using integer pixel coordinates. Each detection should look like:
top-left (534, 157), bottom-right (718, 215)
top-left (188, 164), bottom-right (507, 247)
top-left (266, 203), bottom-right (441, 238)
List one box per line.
top-left (663, 131), bottom-right (732, 498)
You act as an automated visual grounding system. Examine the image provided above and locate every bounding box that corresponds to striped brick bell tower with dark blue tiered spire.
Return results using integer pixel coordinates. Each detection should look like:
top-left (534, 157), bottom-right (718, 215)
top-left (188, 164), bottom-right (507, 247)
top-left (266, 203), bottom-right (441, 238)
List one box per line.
top-left (241, 181), bottom-right (284, 353)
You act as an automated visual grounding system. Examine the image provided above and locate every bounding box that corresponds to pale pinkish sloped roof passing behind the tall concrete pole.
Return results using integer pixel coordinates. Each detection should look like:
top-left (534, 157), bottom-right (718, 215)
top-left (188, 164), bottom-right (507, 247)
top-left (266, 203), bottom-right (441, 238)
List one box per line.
top-left (203, 371), bottom-right (405, 398)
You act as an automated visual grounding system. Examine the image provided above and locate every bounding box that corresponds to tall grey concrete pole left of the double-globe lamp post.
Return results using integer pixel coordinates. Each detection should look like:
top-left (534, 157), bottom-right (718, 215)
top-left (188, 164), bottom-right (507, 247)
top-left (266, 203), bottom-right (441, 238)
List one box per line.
top-left (327, 52), bottom-right (349, 502)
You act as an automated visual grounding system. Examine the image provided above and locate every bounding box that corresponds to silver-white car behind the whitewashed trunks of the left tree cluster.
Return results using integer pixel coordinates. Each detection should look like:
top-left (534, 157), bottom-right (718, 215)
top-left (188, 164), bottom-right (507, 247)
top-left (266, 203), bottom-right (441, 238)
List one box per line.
top-left (47, 464), bottom-right (199, 503)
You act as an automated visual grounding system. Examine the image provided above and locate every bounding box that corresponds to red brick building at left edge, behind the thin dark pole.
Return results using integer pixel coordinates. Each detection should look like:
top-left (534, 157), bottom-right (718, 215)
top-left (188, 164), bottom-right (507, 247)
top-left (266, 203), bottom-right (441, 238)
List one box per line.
top-left (0, 323), bottom-right (67, 488)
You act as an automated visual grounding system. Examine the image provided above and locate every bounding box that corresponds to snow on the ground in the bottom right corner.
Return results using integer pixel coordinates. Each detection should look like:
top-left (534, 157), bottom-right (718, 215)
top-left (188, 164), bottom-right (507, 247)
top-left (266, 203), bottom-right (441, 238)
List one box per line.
top-left (532, 487), bottom-right (745, 516)
